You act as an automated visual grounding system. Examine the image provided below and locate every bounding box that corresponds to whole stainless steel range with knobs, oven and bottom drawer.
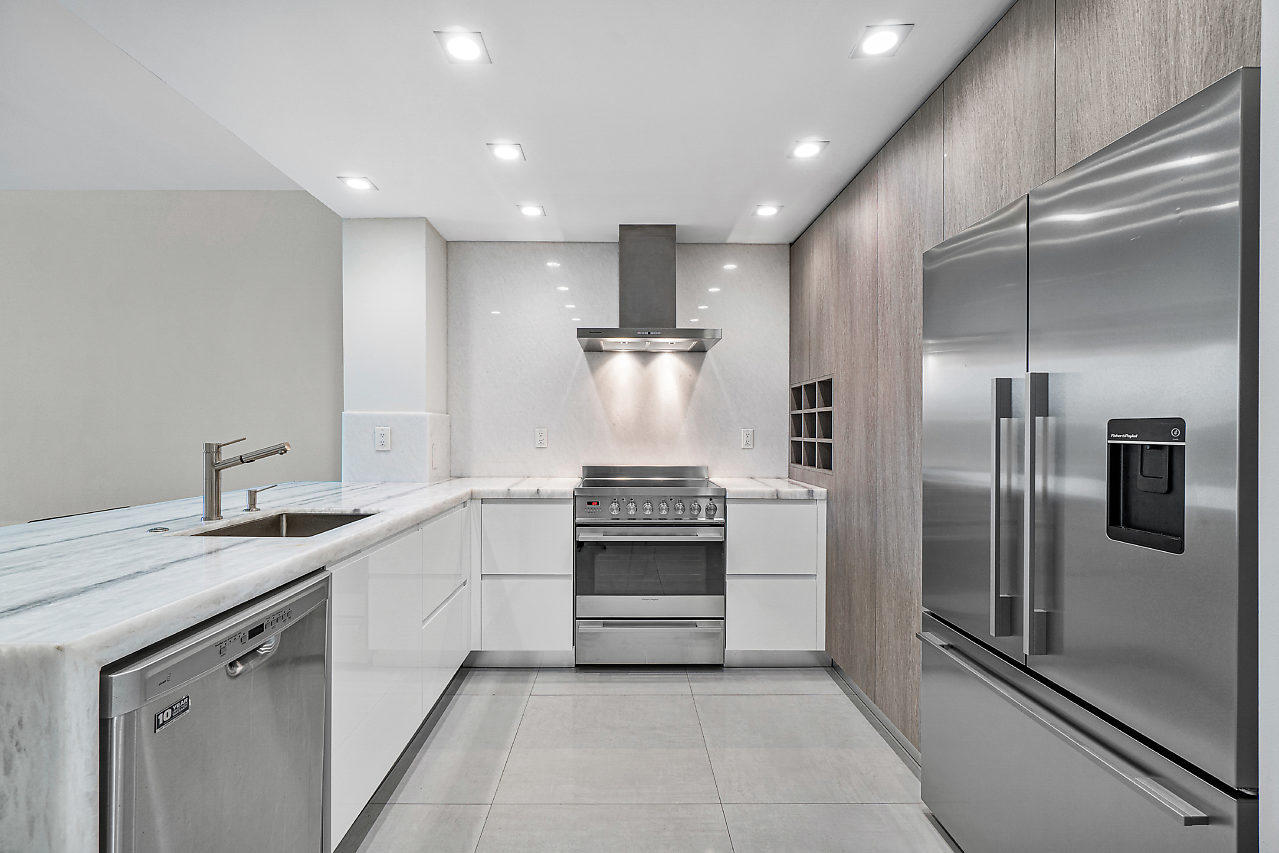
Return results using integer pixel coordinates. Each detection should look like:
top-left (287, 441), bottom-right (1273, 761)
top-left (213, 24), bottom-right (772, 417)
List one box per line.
top-left (573, 466), bottom-right (728, 664)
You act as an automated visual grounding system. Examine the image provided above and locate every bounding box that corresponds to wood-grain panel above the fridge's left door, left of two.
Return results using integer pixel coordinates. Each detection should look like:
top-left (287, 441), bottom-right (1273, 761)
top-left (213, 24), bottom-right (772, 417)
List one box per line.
top-left (946, 0), bottom-right (1053, 239)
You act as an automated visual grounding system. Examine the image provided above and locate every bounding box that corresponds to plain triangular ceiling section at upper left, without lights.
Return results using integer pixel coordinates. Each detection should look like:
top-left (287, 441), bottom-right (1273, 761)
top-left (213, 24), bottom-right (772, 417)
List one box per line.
top-left (0, 0), bottom-right (298, 189)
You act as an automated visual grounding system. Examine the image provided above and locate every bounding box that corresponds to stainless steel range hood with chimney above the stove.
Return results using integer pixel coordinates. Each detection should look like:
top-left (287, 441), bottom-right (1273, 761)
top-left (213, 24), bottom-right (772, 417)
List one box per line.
top-left (577, 225), bottom-right (723, 353)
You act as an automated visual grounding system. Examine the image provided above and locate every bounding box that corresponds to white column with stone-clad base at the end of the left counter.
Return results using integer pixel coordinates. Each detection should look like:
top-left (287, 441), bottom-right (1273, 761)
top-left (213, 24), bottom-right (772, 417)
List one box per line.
top-left (341, 219), bottom-right (449, 482)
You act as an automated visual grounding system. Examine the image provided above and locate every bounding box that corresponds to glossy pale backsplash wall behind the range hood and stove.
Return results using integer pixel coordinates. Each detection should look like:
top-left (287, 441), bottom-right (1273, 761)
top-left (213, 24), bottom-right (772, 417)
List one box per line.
top-left (449, 243), bottom-right (789, 477)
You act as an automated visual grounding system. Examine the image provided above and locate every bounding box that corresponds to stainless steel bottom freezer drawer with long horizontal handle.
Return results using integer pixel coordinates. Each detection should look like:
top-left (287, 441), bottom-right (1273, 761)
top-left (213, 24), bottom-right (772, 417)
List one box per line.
top-left (920, 615), bottom-right (1257, 853)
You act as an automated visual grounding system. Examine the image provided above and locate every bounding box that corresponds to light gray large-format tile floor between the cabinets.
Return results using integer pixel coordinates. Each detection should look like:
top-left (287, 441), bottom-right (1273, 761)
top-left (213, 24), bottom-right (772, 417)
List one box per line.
top-left (359, 668), bottom-right (953, 853)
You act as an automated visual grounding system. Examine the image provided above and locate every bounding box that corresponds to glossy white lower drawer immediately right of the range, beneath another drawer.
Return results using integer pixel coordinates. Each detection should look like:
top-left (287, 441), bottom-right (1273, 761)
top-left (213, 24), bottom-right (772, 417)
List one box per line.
top-left (724, 574), bottom-right (825, 651)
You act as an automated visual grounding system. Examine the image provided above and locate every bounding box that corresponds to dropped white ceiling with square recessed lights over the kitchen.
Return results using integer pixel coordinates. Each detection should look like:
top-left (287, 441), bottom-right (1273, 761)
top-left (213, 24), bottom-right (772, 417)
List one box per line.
top-left (52, 0), bottom-right (1009, 243)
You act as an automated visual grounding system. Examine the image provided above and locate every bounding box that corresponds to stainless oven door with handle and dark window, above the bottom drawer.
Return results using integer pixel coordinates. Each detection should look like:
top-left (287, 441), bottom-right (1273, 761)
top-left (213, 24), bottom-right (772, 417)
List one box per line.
top-left (574, 526), bottom-right (724, 619)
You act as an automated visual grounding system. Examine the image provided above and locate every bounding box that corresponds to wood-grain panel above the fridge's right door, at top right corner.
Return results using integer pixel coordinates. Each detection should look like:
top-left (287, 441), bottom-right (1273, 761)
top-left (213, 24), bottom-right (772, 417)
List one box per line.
top-left (1056, 0), bottom-right (1261, 171)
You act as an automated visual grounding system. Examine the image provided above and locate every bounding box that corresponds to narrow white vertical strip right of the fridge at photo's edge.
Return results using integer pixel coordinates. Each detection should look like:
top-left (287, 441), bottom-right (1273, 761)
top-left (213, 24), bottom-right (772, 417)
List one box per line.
top-left (1257, 0), bottom-right (1279, 853)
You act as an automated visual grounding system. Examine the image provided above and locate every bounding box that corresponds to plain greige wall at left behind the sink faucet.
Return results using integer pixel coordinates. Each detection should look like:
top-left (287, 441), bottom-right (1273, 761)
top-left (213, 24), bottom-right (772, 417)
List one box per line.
top-left (0, 191), bottom-right (341, 523)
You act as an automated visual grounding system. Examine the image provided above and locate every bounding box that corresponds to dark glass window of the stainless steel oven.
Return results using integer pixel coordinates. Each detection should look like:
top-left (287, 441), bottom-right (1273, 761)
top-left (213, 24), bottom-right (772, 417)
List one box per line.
top-left (576, 542), bottom-right (724, 596)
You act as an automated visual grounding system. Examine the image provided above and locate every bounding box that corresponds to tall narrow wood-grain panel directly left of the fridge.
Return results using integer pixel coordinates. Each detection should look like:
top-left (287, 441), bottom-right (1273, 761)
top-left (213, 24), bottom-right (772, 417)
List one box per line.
top-left (875, 92), bottom-right (941, 744)
